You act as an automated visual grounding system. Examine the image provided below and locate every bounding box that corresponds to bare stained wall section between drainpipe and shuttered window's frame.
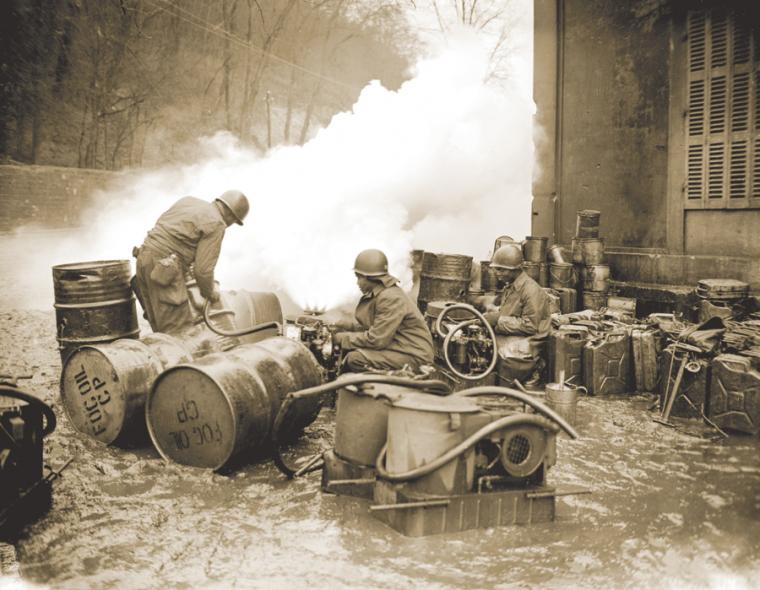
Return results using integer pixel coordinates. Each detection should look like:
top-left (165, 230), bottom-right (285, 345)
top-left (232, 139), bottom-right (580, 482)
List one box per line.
top-left (559, 0), bottom-right (670, 248)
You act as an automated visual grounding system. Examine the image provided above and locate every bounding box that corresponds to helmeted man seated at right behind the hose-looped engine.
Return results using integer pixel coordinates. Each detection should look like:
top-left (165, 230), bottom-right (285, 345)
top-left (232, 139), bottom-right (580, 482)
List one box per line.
top-left (484, 244), bottom-right (551, 385)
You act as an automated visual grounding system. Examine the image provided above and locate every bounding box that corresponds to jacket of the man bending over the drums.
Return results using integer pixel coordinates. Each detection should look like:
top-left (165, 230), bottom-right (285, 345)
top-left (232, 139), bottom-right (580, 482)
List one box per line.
top-left (143, 197), bottom-right (227, 298)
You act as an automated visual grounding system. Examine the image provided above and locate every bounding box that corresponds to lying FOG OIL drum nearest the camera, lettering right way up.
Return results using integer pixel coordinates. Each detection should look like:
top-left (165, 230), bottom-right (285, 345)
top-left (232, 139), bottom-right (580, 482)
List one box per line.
top-left (146, 337), bottom-right (322, 469)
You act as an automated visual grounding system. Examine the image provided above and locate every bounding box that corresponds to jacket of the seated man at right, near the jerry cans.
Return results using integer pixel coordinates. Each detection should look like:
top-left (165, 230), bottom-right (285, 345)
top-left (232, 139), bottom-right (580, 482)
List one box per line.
top-left (494, 271), bottom-right (551, 340)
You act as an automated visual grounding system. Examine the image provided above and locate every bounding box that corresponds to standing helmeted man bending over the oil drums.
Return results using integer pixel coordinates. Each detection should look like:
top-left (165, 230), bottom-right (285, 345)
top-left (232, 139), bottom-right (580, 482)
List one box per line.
top-left (133, 190), bottom-right (250, 332)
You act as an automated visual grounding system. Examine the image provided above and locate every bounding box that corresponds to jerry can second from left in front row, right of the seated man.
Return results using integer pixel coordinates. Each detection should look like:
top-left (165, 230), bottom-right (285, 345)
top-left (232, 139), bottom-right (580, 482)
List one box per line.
top-left (583, 332), bottom-right (632, 395)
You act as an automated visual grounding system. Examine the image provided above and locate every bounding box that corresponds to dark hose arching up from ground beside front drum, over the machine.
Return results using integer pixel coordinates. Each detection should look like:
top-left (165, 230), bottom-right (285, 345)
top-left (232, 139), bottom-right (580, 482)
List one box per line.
top-left (272, 373), bottom-right (451, 479)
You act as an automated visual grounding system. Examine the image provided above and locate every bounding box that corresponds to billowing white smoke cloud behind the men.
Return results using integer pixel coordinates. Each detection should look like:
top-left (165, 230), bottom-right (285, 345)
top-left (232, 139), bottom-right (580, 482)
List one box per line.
top-left (1, 33), bottom-right (534, 314)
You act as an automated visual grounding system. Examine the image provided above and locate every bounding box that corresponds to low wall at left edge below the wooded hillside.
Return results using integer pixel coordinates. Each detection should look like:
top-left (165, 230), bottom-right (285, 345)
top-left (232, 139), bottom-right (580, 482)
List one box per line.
top-left (0, 165), bottom-right (123, 232)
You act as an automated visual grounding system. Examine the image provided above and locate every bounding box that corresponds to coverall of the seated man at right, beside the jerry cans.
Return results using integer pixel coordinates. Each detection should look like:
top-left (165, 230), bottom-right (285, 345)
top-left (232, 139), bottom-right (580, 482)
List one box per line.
top-left (485, 271), bottom-right (551, 378)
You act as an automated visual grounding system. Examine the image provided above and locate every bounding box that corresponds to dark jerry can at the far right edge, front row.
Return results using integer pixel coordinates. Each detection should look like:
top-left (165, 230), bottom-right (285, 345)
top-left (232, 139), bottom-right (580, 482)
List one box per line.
top-left (708, 354), bottom-right (760, 434)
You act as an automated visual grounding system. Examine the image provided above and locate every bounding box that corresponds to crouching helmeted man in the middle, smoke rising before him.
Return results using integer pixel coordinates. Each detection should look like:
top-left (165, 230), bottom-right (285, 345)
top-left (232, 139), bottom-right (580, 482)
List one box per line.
top-left (334, 250), bottom-right (433, 371)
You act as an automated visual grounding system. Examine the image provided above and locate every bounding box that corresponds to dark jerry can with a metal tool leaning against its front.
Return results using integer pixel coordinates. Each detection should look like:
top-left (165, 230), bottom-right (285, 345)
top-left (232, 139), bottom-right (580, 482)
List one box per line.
top-left (657, 346), bottom-right (711, 418)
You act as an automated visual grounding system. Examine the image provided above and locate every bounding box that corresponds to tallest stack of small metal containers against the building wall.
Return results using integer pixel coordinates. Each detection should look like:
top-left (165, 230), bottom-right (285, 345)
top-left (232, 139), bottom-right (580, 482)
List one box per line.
top-left (572, 209), bottom-right (610, 310)
